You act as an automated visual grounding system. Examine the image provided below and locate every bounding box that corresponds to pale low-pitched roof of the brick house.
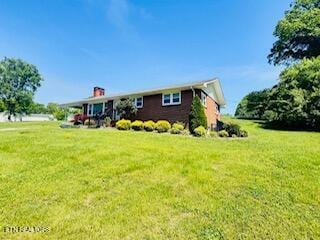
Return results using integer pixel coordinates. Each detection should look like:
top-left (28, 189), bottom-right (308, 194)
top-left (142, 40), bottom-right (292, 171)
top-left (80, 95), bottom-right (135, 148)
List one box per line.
top-left (60, 78), bottom-right (226, 107)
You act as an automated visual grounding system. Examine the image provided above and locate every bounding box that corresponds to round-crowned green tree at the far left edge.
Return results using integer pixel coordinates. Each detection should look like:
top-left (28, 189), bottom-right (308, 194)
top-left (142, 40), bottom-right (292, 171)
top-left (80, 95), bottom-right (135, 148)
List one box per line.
top-left (0, 58), bottom-right (43, 120)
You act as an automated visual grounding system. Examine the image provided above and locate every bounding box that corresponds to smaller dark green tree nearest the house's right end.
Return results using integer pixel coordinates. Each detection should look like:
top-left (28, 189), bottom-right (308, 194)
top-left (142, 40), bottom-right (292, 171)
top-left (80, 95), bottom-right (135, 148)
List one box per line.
top-left (235, 89), bottom-right (270, 119)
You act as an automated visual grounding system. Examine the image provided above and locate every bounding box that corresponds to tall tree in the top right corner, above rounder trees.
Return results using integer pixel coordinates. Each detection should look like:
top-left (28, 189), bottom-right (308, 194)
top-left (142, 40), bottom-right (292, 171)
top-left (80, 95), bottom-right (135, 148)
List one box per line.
top-left (268, 0), bottom-right (320, 65)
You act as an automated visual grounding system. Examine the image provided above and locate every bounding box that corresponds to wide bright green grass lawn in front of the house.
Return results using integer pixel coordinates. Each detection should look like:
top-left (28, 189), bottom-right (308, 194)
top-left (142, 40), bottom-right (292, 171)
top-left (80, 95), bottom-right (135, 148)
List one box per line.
top-left (0, 121), bottom-right (320, 239)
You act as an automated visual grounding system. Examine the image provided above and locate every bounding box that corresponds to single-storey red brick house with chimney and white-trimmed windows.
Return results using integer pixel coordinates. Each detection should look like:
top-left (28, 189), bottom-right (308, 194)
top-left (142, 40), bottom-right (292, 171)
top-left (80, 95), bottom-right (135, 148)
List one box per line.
top-left (61, 79), bottom-right (225, 128)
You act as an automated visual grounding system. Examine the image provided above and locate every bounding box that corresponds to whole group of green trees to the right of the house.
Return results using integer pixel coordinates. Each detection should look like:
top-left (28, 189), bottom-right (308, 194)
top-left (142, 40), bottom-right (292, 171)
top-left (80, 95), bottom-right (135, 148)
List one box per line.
top-left (235, 0), bottom-right (320, 130)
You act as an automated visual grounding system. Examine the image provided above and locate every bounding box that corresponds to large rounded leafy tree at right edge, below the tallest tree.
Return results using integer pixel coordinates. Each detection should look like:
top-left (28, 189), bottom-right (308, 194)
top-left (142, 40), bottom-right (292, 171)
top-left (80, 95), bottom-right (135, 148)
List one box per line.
top-left (265, 57), bottom-right (320, 130)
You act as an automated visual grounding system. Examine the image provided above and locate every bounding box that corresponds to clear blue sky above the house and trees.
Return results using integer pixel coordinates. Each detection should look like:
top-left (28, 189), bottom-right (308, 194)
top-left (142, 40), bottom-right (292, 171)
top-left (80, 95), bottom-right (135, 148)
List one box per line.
top-left (0, 0), bottom-right (291, 113)
